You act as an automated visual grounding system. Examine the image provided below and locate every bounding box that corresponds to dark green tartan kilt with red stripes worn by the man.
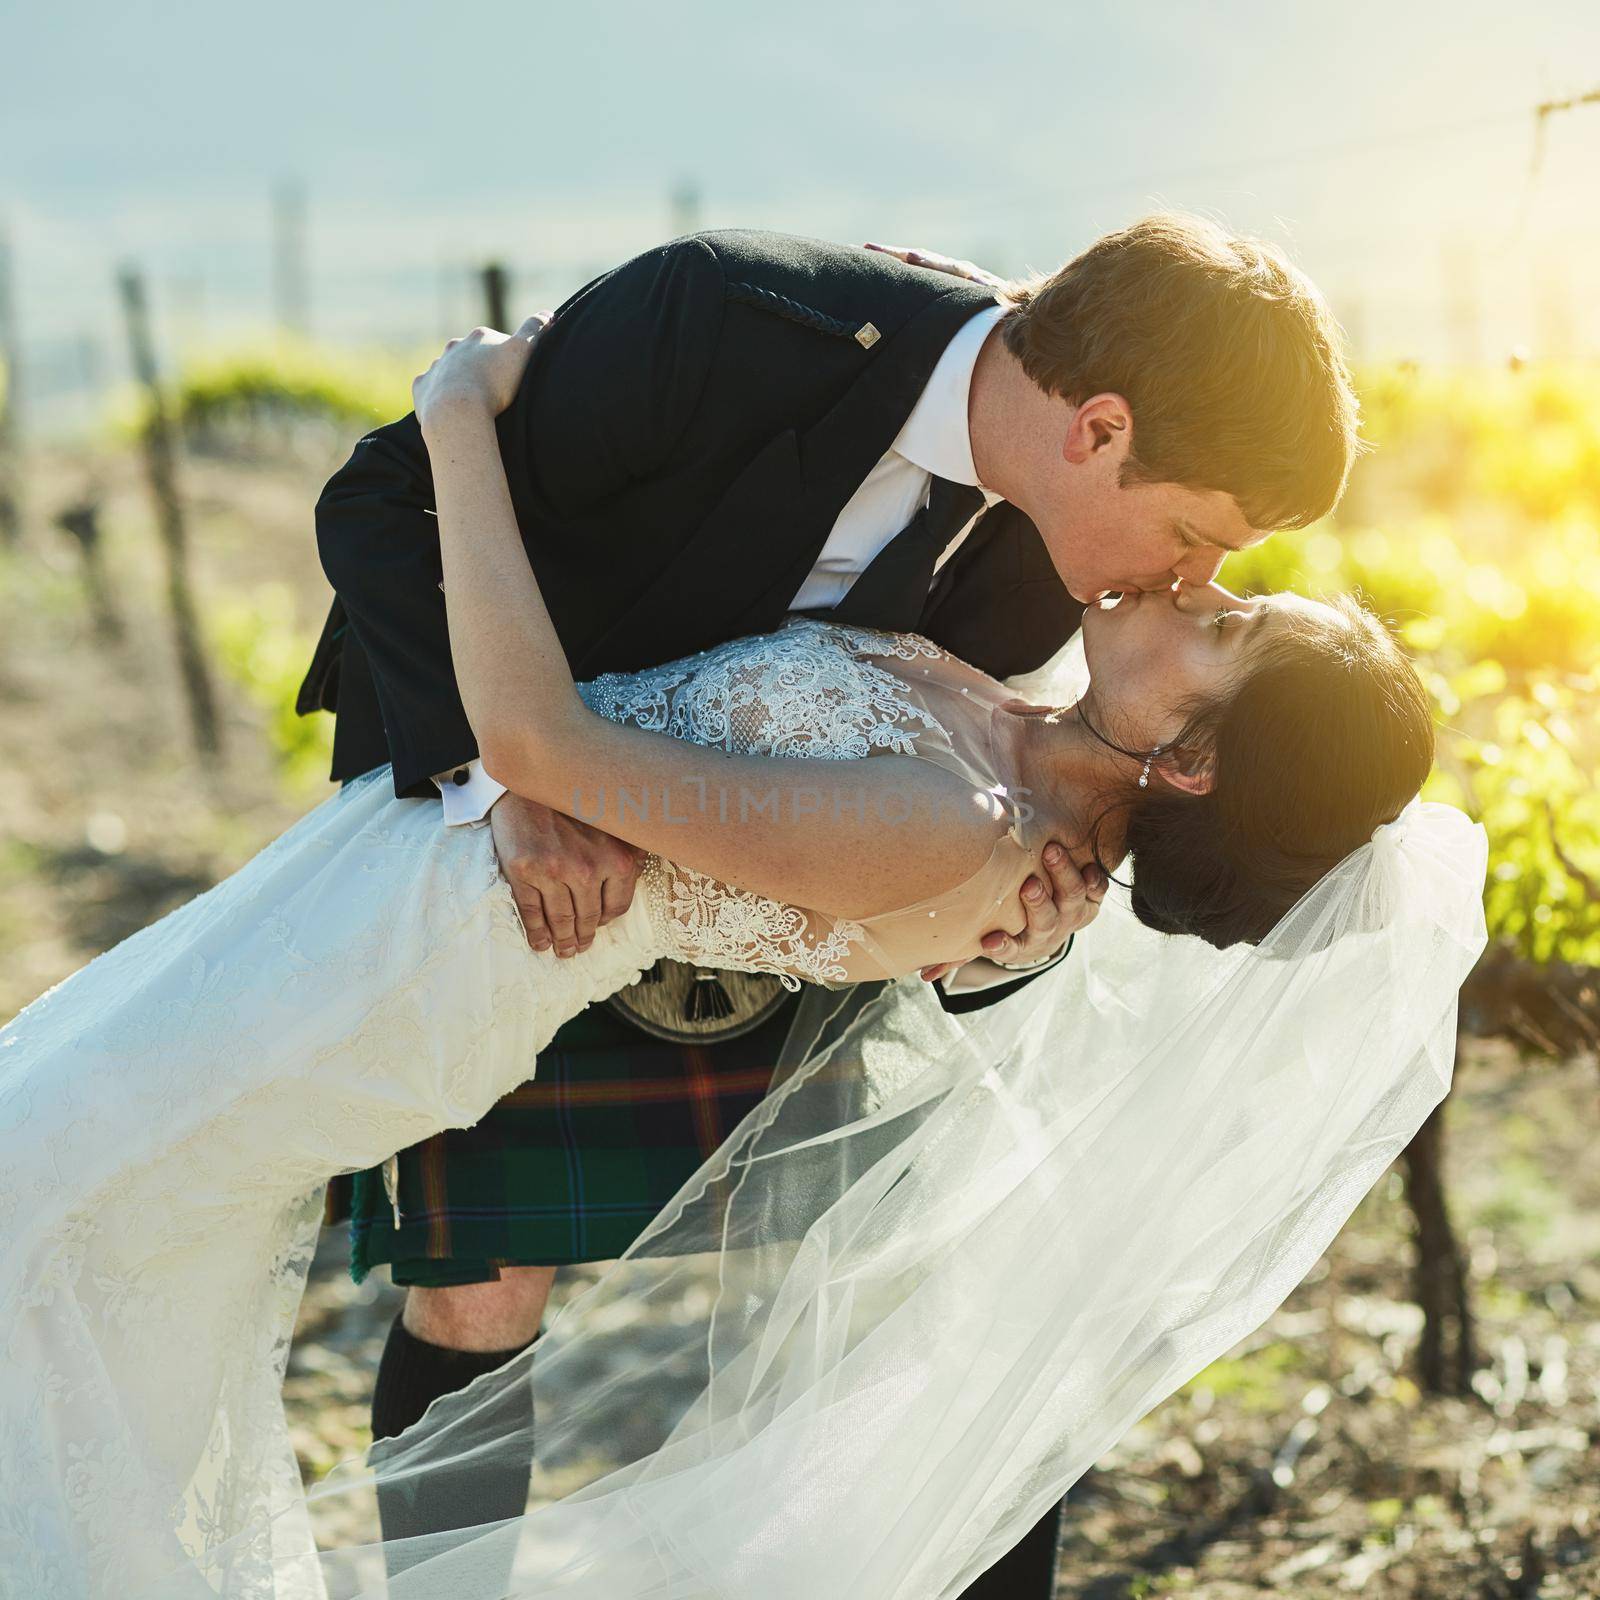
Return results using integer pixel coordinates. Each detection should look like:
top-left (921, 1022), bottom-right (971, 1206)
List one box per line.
top-left (326, 997), bottom-right (797, 1288)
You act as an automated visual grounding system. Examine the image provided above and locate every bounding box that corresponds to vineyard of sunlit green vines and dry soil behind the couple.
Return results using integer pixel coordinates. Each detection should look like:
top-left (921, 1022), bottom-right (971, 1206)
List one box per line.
top-left (0, 346), bottom-right (1600, 1600)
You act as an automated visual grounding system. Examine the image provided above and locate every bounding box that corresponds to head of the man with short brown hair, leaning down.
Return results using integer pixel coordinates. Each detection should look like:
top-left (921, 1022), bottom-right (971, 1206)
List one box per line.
top-left (974, 216), bottom-right (1358, 600)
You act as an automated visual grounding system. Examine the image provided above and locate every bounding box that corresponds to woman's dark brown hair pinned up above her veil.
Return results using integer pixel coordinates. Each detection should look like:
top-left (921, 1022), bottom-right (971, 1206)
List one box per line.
top-left (1126, 598), bottom-right (1434, 949)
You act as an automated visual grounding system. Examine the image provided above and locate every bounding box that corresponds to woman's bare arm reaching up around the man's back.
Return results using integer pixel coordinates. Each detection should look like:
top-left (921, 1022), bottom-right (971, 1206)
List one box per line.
top-left (414, 323), bottom-right (1003, 917)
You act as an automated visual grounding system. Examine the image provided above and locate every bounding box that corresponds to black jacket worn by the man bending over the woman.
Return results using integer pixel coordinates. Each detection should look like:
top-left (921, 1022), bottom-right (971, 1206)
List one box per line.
top-left (298, 230), bottom-right (1082, 795)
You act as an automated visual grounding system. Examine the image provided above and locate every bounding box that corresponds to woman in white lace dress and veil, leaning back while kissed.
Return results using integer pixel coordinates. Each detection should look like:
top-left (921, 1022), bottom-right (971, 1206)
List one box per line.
top-left (0, 323), bottom-right (1483, 1600)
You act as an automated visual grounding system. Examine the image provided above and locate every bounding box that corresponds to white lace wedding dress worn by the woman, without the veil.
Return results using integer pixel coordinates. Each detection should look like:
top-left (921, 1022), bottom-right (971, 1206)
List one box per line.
top-left (0, 619), bottom-right (1032, 1600)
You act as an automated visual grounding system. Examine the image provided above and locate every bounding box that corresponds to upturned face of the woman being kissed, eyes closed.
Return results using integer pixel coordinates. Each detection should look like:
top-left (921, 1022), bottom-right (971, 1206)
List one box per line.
top-left (1083, 582), bottom-right (1349, 750)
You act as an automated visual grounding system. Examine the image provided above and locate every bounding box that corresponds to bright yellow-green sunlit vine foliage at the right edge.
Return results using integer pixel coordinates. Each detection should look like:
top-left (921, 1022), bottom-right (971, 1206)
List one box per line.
top-left (1222, 371), bottom-right (1600, 965)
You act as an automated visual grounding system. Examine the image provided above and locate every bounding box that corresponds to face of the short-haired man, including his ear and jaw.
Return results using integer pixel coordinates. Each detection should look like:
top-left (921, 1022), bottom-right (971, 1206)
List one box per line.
top-left (1022, 395), bottom-right (1267, 603)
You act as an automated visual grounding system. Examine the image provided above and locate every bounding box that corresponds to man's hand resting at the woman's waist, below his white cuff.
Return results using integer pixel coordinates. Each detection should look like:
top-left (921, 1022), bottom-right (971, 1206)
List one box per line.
top-left (490, 794), bottom-right (645, 957)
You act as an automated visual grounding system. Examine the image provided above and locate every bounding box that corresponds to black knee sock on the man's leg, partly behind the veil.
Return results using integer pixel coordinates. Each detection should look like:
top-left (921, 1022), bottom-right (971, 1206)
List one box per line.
top-left (373, 1317), bottom-right (533, 1570)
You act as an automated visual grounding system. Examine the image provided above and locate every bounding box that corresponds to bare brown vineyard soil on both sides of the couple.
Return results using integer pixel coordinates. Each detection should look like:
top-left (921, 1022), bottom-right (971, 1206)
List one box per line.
top-left (0, 456), bottom-right (1600, 1600)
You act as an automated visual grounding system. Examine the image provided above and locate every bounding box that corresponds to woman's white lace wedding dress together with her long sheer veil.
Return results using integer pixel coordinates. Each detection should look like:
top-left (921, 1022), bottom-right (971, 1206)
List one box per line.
top-left (0, 621), bottom-right (1485, 1600)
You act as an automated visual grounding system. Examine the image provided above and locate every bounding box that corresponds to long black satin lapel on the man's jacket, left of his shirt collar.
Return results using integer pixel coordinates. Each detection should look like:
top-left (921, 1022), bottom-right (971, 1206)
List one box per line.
top-left (573, 283), bottom-right (994, 677)
